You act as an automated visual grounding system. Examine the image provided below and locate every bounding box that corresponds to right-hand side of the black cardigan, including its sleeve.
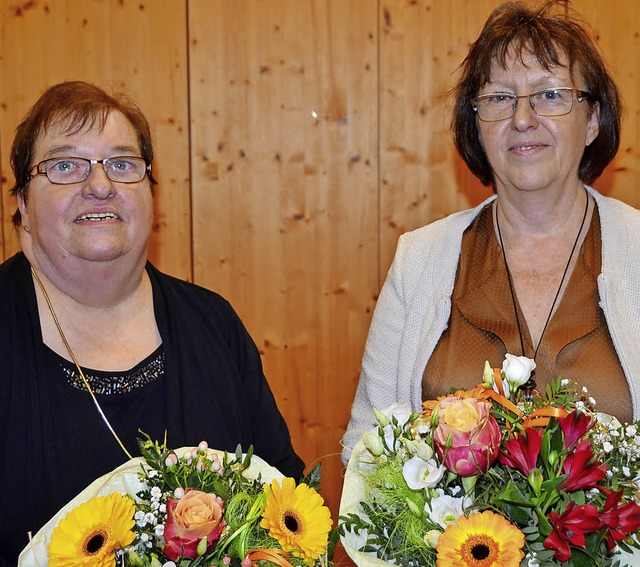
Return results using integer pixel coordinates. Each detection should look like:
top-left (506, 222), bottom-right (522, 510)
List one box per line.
top-left (149, 266), bottom-right (304, 479)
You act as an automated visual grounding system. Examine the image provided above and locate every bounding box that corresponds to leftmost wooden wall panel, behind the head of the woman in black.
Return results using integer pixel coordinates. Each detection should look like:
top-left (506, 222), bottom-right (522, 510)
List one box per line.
top-left (0, 0), bottom-right (191, 279)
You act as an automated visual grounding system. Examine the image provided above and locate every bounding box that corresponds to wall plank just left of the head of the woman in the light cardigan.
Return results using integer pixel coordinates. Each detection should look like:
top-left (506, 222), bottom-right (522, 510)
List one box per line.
top-left (380, 0), bottom-right (499, 280)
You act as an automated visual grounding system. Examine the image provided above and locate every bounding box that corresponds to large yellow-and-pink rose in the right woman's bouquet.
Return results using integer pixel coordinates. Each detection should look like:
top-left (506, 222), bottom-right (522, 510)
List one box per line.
top-left (433, 397), bottom-right (501, 477)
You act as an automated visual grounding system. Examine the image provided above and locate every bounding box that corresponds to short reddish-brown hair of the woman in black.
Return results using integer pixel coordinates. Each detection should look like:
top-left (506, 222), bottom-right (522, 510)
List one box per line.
top-left (10, 81), bottom-right (156, 227)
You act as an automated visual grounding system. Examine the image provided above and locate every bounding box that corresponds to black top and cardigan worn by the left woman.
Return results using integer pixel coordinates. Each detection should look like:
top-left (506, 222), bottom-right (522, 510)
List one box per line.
top-left (0, 253), bottom-right (304, 565)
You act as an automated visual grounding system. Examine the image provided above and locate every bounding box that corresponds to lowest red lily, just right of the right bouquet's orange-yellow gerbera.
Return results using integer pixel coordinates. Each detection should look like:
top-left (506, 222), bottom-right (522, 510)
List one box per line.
top-left (544, 502), bottom-right (602, 561)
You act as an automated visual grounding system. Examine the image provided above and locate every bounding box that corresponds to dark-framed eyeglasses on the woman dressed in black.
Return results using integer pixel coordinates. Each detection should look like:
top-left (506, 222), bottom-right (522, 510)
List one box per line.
top-left (31, 156), bottom-right (151, 185)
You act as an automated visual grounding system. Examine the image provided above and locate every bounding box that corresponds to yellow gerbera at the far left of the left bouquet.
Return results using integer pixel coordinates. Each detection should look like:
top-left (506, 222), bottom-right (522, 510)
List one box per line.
top-left (49, 493), bottom-right (135, 567)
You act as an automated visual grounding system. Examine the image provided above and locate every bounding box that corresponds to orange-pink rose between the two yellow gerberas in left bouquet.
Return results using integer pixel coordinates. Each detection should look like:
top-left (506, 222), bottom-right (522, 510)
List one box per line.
top-left (164, 489), bottom-right (226, 561)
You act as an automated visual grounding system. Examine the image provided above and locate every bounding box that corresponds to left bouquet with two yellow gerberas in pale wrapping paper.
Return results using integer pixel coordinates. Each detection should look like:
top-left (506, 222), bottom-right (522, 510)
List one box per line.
top-left (19, 437), bottom-right (332, 567)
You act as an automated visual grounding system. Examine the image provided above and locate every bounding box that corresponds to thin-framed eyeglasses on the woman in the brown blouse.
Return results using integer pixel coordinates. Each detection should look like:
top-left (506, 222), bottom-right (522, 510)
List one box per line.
top-left (471, 87), bottom-right (590, 122)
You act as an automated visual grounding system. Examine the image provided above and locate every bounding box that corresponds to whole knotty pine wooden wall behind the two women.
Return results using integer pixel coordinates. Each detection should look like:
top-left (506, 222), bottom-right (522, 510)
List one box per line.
top-left (0, 0), bottom-right (640, 552)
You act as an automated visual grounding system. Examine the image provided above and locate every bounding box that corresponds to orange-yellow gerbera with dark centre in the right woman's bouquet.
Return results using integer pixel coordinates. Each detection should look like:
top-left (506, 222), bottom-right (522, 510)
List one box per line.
top-left (436, 511), bottom-right (524, 567)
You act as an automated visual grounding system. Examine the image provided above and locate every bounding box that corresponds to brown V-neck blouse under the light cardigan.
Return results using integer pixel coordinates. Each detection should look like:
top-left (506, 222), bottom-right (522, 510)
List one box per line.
top-left (422, 204), bottom-right (633, 422)
